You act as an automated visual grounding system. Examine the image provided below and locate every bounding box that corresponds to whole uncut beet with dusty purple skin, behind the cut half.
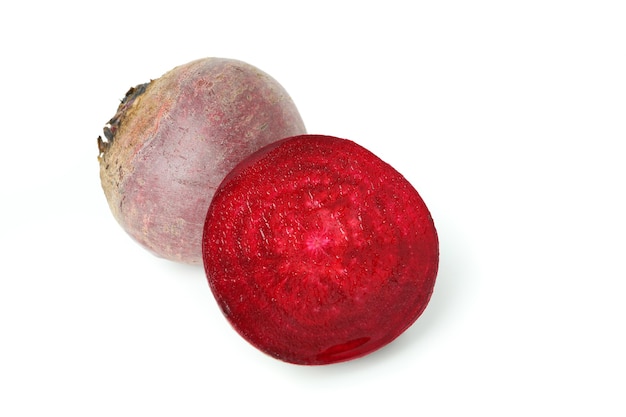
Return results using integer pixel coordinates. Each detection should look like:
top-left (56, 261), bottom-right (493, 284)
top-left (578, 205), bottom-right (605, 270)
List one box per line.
top-left (98, 58), bottom-right (305, 264)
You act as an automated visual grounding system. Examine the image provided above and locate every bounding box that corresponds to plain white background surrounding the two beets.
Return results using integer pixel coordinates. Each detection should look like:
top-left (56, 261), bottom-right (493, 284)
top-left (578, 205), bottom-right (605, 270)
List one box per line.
top-left (0, 0), bottom-right (626, 417)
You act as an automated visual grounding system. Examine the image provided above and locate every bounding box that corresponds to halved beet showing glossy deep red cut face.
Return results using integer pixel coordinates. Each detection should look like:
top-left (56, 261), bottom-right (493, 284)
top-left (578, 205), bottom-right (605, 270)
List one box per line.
top-left (203, 135), bottom-right (439, 365)
